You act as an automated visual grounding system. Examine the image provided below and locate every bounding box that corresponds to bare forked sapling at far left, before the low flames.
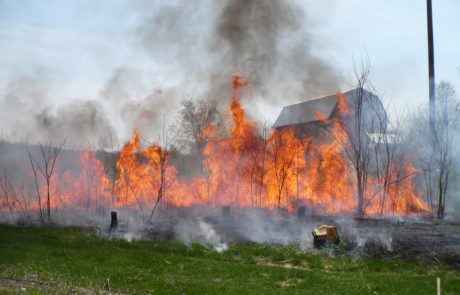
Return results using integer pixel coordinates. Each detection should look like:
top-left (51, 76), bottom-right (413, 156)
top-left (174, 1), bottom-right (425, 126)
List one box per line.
top-left (27, 136), bottom-right (66, 223)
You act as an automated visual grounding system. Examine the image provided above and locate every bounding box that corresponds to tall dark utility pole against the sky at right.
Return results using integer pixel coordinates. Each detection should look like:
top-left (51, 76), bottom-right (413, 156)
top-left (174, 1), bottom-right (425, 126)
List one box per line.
top-left (426, 0), bottom-right (436, 125)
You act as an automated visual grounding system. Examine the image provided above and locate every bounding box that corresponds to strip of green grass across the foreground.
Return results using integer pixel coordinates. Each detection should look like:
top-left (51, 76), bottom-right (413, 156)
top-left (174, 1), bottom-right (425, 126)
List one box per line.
top-left (0, 225), bottom-right (460, 294)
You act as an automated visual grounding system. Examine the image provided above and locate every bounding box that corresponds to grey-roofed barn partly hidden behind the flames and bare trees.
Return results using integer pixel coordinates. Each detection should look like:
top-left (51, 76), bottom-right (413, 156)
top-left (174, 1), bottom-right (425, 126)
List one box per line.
top-left (273, 89), bottom-right (388, 139)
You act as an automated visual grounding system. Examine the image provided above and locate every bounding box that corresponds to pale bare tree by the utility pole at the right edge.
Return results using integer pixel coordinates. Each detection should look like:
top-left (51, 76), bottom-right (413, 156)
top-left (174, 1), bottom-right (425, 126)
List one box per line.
top-left (410, 81), bottom-right (460, 219)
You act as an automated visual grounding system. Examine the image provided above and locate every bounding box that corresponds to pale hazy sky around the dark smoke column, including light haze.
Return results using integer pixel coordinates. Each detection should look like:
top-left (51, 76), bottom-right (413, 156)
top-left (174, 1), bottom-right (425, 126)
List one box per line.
top-left (0, 0), bottom-right (460, 146)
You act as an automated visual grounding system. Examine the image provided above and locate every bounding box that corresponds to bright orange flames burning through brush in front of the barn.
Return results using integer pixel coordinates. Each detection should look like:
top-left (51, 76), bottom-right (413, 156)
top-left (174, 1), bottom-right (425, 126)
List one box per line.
top-left (1, 75), bottom-right (428, 216)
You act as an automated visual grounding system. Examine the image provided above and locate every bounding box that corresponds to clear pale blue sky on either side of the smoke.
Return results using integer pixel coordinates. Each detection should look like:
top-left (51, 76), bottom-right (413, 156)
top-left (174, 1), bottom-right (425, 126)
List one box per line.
top-left (0, 0), bottom-right (460, 145)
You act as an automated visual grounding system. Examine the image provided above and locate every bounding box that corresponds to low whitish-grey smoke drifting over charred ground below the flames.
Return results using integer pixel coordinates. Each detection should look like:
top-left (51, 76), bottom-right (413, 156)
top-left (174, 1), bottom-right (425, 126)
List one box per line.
top-left (0, 206), bottom-right (397, 257)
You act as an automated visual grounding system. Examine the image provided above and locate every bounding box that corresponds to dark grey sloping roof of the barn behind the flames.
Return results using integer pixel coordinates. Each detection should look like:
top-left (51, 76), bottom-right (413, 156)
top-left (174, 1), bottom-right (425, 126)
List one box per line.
top-left (273, 89), bottom-right (370, 128)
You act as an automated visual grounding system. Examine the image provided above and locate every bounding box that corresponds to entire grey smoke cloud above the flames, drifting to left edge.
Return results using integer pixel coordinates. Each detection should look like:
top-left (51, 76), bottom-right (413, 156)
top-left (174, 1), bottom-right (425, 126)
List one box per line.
top-left (0, 0), bottom-right (339, 148)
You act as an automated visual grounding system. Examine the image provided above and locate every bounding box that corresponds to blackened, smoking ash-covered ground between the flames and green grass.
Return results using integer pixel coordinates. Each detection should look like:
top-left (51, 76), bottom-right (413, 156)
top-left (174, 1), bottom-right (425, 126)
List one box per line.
top-left (98, 206), bottom-right (460, 268)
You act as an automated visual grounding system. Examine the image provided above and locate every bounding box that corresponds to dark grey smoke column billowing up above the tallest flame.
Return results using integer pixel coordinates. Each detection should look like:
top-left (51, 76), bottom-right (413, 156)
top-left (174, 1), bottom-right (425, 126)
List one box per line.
top-left (137, 0), bottom-right (340, 110)
